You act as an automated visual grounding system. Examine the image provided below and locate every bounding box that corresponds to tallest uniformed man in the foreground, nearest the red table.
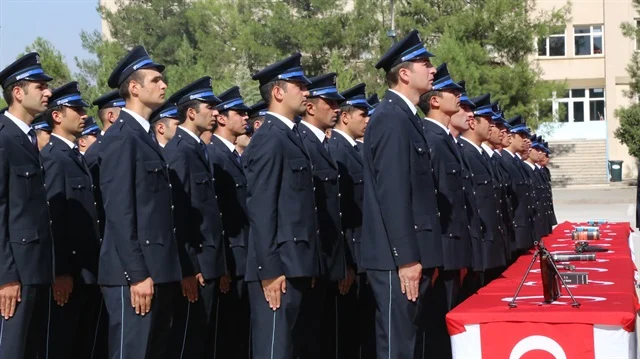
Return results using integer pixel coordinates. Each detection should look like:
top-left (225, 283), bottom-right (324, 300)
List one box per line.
top-left (361, 30), bottom-right (443, 358)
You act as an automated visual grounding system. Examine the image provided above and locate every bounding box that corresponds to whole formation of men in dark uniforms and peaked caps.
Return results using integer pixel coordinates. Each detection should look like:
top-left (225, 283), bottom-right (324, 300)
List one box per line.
top-left (0, 28), bottom-right (552, 358)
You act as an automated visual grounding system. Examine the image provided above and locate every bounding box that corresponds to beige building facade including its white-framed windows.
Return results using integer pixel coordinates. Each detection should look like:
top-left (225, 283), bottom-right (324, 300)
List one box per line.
top-left (533, 0), bottom-right (640, 178)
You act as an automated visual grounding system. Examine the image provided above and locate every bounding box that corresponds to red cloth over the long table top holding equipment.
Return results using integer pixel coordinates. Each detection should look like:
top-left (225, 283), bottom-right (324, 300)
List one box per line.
top-left (447, 222), bottom-right (640, 338)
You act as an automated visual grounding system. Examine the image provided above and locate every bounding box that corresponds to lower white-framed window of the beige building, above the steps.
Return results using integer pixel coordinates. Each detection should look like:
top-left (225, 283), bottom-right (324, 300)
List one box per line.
top-left (554, 88), bottom-right (605, 122)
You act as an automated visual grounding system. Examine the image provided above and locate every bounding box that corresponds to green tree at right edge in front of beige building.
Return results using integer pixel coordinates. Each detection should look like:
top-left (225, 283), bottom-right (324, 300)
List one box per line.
top-left (614, 0), bottom-right (640, 158)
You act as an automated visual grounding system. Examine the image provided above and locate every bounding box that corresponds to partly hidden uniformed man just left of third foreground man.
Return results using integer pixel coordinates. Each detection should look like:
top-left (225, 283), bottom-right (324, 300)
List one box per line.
top-left (208, 86), bottom-right (251, 358)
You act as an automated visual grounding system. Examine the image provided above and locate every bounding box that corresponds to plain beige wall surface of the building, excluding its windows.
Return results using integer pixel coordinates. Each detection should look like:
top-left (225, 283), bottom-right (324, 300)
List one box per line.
top-left (537, 0), bottom-right (639, 178)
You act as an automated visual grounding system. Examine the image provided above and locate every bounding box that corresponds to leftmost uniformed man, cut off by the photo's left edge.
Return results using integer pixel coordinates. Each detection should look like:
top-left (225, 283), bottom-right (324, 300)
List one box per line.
top-left (0, 52), bottom-right (54, 358)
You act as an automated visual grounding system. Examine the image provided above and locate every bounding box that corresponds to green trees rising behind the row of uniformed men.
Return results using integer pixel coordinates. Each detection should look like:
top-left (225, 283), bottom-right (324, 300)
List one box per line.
top-left (1, 0), bottom-right (568, 131)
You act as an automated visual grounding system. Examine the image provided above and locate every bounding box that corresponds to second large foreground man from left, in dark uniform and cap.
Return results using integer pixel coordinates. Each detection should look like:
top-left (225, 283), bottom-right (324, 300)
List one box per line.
top-left (98, 46), bottom-right (182, 359)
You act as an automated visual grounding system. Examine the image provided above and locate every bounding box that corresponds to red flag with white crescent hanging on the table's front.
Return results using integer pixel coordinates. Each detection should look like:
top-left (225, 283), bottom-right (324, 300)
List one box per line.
top-left (480, 324), bottom-right (595, 359)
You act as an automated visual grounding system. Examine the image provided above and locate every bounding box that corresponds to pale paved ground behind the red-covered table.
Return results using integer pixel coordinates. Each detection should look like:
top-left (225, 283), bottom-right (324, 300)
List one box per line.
top-left (553, 184), bottom-right (640, 342)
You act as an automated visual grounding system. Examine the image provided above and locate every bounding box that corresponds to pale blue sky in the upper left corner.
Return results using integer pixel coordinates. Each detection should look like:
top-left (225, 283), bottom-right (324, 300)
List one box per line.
top-left (0, 0), bottom-right (101, 73)
